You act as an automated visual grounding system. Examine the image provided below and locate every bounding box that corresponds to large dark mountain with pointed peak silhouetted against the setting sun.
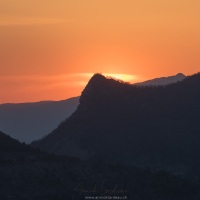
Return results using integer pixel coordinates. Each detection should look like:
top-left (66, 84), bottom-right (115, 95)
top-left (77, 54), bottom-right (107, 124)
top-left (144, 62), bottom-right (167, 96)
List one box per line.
top-left (32, 74), bottom-right (200, 176)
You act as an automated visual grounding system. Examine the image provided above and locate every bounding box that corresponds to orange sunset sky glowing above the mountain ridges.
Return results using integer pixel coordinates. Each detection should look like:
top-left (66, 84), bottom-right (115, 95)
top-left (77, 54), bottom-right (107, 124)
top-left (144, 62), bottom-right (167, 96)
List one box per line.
top-left (0, 0), bottom-right (200, 103)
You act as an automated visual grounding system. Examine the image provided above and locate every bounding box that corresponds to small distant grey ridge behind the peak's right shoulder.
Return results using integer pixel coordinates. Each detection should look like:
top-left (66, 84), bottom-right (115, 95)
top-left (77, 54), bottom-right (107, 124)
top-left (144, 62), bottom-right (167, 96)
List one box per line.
top-left (136, 73), bottom-right (186, 86)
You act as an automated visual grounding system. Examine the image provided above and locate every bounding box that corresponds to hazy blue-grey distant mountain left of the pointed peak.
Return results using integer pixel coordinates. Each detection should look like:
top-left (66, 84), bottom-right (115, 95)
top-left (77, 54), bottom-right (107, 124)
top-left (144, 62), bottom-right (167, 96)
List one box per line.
top-left (0, 97), bottom-right (79, 143)
